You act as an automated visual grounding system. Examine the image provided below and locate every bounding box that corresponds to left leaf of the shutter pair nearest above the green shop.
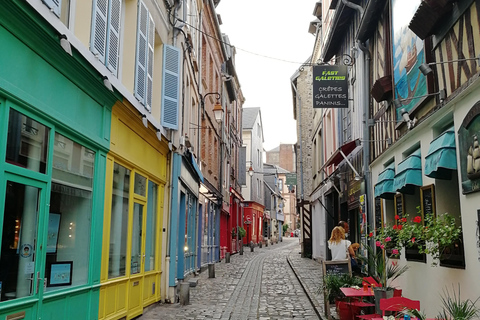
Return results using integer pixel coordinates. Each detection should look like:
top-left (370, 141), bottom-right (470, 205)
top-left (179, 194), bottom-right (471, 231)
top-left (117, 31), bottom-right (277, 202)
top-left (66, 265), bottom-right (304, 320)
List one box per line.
top-left (90, 0), bottom-right (108, 63)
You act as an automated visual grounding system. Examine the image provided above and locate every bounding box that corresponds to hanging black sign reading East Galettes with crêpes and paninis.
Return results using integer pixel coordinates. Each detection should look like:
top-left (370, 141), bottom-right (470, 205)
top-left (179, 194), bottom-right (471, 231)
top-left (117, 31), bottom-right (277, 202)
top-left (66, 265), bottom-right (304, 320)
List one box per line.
top-left (313, 65), bottom-right (348, 108)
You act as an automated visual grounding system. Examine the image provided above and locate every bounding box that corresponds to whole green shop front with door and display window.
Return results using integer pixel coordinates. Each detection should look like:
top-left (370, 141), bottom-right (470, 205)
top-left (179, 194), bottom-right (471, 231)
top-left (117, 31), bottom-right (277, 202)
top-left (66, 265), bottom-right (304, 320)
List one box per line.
top-left (0, 1), bottom-right (116, 320)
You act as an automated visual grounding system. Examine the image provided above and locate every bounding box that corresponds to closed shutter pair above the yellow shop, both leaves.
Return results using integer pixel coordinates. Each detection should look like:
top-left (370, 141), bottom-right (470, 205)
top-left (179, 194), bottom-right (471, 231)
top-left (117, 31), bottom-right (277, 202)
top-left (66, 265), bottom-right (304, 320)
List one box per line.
top-left (135, 1), bottom-right (155, 111)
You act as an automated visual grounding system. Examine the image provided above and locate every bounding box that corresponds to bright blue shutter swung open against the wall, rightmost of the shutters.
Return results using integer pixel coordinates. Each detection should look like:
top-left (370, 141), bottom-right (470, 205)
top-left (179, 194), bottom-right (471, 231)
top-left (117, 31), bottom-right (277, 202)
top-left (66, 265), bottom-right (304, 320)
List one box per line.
top-left (162, 45), bottom-right (180, 130)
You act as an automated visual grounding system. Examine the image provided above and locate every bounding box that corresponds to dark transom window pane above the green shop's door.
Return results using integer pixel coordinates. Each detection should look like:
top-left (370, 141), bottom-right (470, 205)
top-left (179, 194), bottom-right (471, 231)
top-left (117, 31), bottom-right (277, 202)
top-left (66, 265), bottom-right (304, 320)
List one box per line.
top-left (6, 109), bottom-right (50, 173)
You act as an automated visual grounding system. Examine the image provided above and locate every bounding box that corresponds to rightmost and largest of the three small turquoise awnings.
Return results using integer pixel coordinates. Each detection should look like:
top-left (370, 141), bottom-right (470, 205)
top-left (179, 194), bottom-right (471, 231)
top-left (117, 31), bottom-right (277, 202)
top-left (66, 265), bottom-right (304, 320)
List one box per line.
top-left (425, 128), bottom-right (457, 180)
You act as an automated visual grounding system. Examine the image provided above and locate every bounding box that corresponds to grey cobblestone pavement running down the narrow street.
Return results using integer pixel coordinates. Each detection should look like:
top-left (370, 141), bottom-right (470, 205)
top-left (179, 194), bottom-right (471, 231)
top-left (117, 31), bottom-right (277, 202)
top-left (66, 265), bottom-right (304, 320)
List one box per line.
top-left (137, 238), bottom-right (323, 320)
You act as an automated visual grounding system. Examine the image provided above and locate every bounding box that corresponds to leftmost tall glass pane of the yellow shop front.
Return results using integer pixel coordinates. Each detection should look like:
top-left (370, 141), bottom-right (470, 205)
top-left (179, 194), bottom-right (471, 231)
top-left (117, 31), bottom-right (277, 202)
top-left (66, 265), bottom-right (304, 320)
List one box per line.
top-left (108, 163), bottom-right (130, 278)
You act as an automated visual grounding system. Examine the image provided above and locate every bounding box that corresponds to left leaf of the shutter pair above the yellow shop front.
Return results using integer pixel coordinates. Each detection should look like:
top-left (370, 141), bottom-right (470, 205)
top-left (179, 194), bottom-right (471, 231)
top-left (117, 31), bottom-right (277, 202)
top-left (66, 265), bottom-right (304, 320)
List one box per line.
top-left (135, 1), bottom-right (148, 105)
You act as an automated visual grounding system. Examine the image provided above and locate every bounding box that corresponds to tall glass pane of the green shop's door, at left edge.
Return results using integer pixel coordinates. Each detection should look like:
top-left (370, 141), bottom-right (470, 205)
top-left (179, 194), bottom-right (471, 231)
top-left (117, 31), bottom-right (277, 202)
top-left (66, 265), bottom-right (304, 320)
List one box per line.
top-left (0, 181), bottom-right (40, 301)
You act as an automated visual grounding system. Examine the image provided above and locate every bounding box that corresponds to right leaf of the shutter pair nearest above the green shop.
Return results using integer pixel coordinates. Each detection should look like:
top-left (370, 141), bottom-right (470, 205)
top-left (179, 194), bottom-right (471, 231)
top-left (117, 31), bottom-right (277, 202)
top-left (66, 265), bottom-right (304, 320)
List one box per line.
top-left (106, 0), bottom-right (122, 75)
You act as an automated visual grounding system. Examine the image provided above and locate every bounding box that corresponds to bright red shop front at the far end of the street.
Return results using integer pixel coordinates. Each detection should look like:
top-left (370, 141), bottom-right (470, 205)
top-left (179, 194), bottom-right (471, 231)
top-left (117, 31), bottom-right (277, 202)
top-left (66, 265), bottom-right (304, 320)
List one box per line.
top-left (243, 201), bottom-right (265, 245)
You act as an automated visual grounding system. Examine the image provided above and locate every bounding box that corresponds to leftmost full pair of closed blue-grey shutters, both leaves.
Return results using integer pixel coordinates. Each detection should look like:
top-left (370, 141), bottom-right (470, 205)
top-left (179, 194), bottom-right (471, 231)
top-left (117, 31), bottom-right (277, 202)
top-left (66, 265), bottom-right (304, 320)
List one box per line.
top-left (90, 0), bottom-right (122, 76)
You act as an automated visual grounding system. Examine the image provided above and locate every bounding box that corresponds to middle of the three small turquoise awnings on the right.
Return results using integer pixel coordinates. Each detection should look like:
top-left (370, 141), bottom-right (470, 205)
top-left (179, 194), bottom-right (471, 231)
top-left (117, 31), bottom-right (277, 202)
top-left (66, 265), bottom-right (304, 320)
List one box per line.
top-left (393, 149), bottom-right (422, 194)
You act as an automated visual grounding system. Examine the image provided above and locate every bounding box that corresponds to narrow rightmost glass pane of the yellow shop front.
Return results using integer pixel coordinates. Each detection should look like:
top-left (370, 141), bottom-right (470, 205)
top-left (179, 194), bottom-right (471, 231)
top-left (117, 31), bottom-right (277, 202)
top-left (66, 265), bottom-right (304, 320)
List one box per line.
top-left (145, 181), bottom-right (158, 271)
